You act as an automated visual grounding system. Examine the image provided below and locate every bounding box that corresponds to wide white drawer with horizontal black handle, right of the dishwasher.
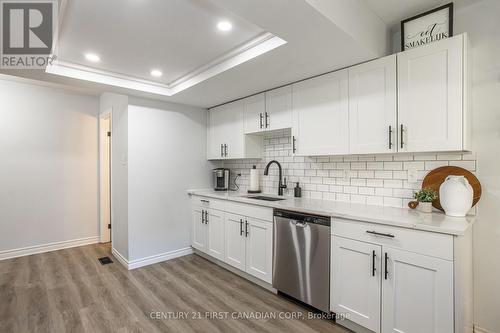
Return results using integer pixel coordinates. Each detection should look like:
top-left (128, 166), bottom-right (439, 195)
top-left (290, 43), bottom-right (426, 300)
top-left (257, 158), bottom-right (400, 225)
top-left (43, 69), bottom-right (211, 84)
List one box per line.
top-left (332, 218), bottom-right (453, 260)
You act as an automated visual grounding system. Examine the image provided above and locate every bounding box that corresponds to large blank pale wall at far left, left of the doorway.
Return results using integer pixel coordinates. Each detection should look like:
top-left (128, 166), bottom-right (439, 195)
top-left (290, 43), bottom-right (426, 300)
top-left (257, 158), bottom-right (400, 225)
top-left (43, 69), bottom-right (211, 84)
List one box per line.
top-left (0, 77), bottom-right (99, 252)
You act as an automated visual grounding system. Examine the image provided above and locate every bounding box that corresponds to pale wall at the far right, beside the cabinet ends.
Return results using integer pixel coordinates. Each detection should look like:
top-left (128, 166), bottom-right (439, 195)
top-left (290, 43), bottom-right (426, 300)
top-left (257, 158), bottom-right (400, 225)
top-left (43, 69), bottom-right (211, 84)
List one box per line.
top-left (393, 0), bottom-right (500, 332)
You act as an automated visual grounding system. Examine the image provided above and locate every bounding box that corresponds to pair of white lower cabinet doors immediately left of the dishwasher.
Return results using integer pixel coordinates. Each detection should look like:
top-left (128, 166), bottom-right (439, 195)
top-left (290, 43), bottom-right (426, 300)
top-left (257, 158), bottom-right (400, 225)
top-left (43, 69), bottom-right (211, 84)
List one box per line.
top-left (224, 213), bottom-right (273, 283)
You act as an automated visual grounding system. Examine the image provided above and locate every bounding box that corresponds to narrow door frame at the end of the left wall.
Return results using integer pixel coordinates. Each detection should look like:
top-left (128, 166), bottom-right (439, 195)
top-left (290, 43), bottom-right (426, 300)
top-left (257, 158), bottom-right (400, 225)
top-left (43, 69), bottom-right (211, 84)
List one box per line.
top-left (99, 108), bottom-right (113, 243)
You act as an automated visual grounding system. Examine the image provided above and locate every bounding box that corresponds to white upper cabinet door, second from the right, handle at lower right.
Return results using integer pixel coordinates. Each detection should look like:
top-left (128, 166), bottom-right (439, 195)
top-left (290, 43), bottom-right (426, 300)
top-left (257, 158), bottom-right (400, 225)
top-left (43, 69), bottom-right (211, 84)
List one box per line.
top-left (349, 55), bottom-right (397, 154)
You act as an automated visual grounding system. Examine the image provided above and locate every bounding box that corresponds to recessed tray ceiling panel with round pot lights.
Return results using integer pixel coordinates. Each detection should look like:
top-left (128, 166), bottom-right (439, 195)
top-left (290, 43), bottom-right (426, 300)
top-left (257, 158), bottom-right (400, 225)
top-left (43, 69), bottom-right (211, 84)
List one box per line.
top-left (58, 0), bottom-right (265, 84)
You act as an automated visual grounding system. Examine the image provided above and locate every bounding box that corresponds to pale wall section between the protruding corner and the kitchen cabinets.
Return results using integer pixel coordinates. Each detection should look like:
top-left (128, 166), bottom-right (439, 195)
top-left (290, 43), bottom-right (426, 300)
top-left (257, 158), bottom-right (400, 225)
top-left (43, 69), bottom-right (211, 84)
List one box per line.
top-left (128, 99), bottom-right (214, 261)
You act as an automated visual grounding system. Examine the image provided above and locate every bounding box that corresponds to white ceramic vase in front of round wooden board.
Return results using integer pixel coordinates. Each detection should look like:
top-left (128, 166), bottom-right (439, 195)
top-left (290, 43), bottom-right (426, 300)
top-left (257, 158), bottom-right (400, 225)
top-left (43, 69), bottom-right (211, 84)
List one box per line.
top-left (439, 176), bottom-right (474, 217)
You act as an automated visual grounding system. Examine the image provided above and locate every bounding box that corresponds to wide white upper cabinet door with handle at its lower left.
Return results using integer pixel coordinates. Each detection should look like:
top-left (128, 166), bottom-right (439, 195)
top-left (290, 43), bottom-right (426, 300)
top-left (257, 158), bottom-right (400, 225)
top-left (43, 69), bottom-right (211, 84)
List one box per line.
top-left (292, 70), bottom-right (349, 156)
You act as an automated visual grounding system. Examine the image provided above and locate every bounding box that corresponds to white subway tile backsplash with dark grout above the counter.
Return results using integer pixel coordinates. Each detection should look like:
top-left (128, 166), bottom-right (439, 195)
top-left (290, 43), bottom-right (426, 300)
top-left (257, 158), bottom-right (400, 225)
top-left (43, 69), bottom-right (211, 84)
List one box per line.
top-left (222, 130), bottom-right (476, 207)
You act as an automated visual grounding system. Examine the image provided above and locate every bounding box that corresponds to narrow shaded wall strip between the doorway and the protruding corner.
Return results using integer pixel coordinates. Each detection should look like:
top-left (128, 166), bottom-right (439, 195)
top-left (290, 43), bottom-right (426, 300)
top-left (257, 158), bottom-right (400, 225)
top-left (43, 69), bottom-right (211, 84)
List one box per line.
top-left (100, 93), bottom-right (129, 260)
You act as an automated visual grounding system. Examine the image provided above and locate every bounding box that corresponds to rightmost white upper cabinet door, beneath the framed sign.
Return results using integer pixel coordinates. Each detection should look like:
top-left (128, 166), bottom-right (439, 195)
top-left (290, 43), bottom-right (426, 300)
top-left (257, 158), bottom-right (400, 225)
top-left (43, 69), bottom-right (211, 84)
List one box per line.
top-left (398, 35), bottom-right (469, 152)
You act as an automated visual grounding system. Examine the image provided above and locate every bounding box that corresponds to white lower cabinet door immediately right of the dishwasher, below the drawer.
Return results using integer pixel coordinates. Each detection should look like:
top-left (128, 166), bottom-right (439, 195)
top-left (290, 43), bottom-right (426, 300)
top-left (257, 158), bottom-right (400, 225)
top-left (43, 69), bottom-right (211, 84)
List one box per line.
top-left (331, 236), bottom-right (382, 333)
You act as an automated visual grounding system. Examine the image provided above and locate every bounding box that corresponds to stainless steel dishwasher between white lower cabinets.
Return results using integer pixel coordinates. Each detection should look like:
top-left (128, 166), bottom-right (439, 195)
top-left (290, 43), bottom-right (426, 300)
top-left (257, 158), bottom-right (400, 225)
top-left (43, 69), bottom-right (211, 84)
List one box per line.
top-left (273, 210), bottom-right (330, 312)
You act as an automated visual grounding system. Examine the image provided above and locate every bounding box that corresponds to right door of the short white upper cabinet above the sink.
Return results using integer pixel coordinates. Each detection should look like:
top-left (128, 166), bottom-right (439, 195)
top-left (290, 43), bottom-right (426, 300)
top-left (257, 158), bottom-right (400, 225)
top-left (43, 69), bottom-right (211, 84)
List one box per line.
top-left (264, 85), bottom-right (292, 131)
